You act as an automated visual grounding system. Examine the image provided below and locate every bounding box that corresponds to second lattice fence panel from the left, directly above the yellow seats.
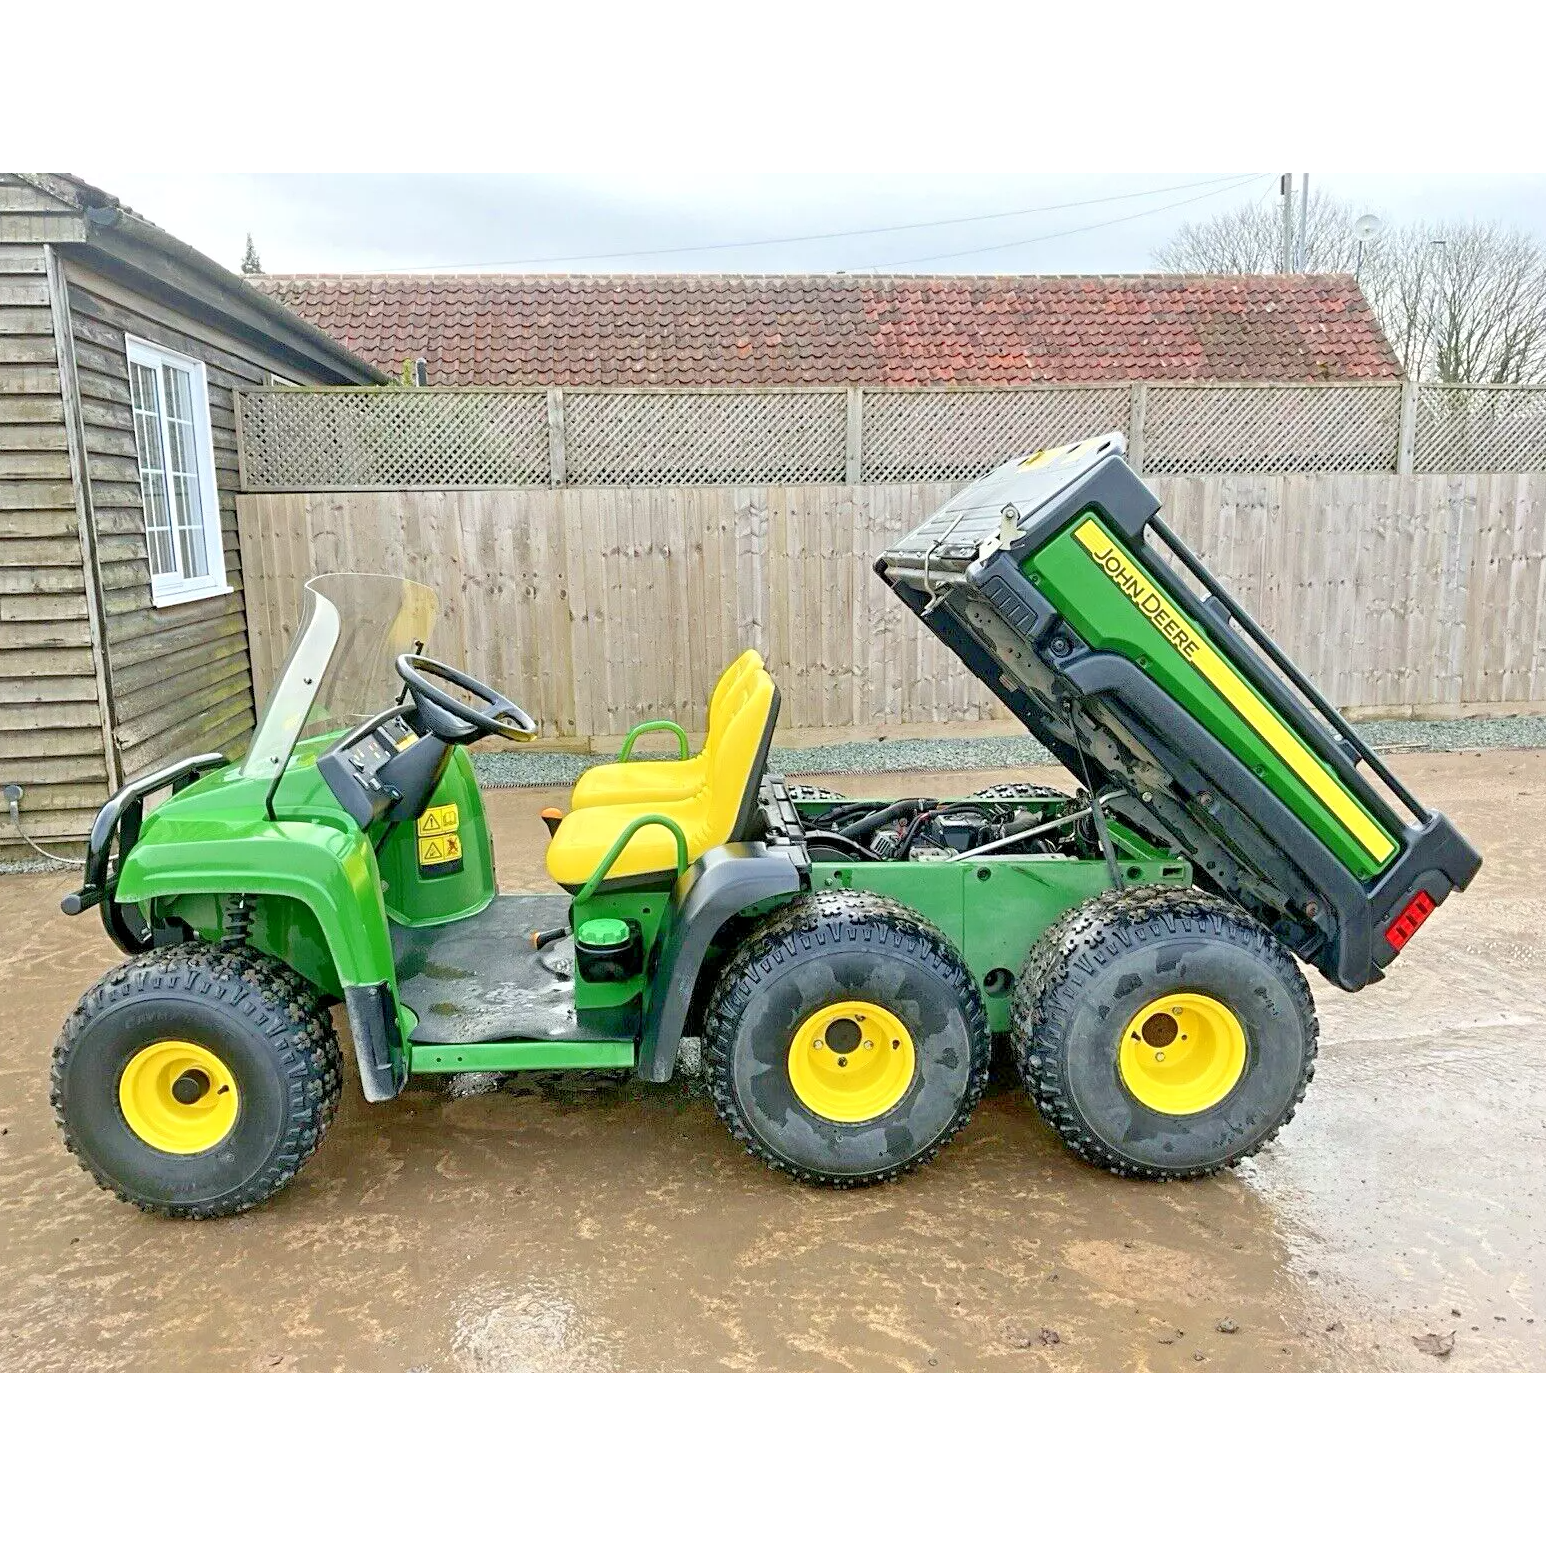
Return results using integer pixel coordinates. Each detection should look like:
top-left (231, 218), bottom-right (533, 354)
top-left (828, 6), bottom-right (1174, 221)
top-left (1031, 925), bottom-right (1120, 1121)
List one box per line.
top-left (564, 391), bottom-right (847, 487)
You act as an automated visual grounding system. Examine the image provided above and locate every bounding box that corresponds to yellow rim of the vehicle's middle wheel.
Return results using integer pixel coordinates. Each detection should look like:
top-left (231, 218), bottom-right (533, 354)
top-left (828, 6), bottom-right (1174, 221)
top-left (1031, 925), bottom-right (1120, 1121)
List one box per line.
top-left (788, 999), bottom-right (918, 1122)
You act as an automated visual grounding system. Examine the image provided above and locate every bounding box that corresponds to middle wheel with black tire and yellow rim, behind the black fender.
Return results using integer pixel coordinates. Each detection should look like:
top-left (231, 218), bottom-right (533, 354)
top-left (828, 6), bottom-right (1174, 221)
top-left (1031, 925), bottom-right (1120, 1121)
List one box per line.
top-left (703, 890), bottom-right (991, 1186)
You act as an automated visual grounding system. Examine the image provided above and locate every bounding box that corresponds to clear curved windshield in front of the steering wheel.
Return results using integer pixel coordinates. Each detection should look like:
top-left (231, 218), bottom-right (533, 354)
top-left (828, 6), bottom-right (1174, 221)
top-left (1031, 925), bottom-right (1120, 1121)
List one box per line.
top-left (241, 574), bottom-right (438, 776)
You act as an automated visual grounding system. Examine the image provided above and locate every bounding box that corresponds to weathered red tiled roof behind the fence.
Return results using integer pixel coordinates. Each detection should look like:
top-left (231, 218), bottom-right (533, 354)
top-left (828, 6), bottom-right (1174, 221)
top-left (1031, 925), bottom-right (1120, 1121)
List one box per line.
top-left (254, 274), bottom-right (1401, 387)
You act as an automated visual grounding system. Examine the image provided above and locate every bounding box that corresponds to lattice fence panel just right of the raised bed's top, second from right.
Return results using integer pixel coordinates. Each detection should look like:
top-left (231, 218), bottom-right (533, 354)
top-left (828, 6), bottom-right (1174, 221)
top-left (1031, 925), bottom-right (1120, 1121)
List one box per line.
top-left (1142, 383), bottom-right (1401, 475)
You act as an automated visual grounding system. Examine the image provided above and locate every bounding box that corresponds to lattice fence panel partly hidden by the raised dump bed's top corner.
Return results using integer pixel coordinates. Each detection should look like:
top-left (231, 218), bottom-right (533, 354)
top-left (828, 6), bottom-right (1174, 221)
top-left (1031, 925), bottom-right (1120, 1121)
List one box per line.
top-left (861, 387), bottom-right (1129, 482)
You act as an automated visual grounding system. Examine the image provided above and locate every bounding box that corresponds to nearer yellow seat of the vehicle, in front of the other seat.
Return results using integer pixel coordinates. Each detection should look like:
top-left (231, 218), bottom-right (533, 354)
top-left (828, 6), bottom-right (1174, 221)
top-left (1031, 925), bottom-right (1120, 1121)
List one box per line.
top-left (547, 666), bottom-right (778, 890)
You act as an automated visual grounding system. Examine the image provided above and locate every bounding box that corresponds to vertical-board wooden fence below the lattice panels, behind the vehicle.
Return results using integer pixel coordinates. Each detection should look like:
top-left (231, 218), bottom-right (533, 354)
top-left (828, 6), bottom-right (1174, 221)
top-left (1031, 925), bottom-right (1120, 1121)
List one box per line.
top-left (240, 473), bottom-right (1546, 737)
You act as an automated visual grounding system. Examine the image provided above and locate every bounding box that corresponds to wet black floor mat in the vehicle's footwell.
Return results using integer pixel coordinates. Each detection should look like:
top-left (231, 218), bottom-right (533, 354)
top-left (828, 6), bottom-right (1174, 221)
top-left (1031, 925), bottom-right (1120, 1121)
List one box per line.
top-left (391, 895), bottom-right (580, 1047)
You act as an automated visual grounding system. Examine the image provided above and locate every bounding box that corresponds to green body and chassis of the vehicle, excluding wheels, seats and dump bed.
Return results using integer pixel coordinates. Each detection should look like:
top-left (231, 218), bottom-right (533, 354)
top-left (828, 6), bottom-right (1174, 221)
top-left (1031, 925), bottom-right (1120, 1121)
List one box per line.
top-left (78, 731), bottom-right (1174, 1101)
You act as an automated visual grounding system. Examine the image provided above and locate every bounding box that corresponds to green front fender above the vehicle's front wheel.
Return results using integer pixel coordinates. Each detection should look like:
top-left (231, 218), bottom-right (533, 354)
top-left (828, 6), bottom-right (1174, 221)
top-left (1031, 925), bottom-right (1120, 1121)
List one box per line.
top-left (116, 801), bottom-right (396, 997)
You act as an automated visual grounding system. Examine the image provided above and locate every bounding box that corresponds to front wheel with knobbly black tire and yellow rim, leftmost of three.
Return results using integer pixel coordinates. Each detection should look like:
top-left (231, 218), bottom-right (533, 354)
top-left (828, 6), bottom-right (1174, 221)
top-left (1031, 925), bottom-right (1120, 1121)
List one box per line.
top-left (51, 945), bottom-right (343, 1218)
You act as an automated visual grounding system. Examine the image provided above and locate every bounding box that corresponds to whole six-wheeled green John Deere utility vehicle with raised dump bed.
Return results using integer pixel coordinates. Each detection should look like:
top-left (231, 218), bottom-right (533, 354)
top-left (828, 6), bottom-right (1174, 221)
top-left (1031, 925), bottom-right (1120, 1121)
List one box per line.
top-left (56, 436), bottom-right (1480, 1217)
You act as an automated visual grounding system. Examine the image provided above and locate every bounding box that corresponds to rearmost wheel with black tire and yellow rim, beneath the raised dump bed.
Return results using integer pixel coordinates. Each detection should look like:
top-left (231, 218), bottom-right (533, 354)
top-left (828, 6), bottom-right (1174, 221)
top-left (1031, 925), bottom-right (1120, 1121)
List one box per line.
top-left (1011, 886), bottom-right (1319, 1181)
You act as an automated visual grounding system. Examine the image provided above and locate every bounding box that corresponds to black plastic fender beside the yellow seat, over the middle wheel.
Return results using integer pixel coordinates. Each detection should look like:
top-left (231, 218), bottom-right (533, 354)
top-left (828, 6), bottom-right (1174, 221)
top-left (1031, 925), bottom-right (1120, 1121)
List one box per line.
top-left (635, 843), bottom-right (804, 1084)
